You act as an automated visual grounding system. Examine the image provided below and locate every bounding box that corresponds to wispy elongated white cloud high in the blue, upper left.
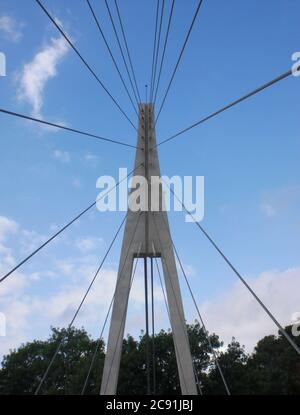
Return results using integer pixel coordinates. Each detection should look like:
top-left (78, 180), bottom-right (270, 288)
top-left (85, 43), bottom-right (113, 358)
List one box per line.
top-left (18, 36), bottom-right (68, 118)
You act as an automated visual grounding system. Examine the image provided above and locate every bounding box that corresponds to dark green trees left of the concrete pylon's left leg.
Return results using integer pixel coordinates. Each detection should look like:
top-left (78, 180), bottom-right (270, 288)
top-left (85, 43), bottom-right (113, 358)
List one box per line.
top-left (0, 328), bottom-right (104, 394)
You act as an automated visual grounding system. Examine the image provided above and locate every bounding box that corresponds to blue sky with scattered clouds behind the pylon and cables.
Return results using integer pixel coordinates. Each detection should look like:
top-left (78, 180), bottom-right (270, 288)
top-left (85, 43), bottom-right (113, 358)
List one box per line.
top-left (0, 0), bottom-right (300, 353)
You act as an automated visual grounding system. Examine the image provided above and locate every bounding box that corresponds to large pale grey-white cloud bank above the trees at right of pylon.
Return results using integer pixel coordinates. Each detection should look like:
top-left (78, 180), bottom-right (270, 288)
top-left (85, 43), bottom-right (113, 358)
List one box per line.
top-left (201, 268), bottom-right (300, 351)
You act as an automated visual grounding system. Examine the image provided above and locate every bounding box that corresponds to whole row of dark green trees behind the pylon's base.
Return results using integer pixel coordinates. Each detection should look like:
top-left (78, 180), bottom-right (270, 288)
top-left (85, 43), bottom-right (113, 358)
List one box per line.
top-left (0, 321), bottom-right (300, 395)
